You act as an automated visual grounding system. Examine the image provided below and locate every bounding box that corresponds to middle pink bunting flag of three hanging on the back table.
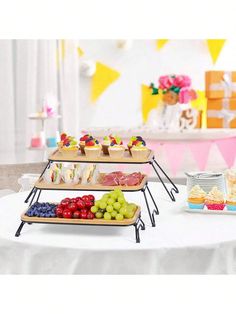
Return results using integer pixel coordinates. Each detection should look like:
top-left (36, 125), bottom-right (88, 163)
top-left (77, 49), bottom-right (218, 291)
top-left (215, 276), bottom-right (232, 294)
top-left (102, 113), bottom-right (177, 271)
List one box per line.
top-left (188, 141), bottom-right (212, 171)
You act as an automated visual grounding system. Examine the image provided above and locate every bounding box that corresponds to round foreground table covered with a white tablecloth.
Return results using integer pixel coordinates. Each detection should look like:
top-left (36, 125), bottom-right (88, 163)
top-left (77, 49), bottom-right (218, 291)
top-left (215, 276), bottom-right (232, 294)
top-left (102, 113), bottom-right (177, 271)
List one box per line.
top-left (0, 182), bottom-right (236, 274)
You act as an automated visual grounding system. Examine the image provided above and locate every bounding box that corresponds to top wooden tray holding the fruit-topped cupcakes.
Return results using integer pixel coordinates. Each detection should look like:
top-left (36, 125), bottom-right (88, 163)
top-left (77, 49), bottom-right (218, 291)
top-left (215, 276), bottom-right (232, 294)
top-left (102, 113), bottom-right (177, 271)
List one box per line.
top-left (48, 149), bottom-right (154, 164)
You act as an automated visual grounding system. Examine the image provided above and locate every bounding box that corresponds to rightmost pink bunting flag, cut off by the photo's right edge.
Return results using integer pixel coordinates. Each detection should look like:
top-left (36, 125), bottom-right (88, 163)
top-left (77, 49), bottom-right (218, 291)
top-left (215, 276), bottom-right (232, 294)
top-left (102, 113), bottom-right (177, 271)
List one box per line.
top-left (215, 137), bottom-right (236, 168)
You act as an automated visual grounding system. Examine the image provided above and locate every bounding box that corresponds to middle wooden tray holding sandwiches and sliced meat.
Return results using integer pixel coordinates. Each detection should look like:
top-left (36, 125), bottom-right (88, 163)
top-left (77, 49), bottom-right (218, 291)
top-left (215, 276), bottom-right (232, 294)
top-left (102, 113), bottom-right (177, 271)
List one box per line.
top-left (34, 173), bottom-right (147, 191)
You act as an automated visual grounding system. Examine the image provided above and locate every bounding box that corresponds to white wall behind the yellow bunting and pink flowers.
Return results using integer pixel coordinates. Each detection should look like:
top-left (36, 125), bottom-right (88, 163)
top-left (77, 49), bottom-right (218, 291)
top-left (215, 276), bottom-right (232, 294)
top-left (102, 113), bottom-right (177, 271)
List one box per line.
top-left (80, 40), bottom-right (236, 129)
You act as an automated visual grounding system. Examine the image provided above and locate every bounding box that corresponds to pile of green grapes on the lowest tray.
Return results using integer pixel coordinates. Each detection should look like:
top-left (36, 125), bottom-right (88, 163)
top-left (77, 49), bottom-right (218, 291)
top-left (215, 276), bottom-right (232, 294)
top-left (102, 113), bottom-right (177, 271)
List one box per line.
top-left (91, 189), bottom-right (137, 220)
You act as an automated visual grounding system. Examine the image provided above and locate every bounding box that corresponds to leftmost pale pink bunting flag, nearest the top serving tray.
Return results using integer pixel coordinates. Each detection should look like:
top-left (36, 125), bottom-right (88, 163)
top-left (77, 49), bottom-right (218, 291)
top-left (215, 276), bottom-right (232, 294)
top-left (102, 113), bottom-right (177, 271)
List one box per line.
top-left (163, 142), bottom-right (185, 176)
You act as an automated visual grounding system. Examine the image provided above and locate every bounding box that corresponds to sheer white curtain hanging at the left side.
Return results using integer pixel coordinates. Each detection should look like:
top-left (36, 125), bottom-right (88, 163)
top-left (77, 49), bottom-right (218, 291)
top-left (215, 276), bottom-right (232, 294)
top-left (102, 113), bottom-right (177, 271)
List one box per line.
top-left (0, 40), bottom-right (79, 152)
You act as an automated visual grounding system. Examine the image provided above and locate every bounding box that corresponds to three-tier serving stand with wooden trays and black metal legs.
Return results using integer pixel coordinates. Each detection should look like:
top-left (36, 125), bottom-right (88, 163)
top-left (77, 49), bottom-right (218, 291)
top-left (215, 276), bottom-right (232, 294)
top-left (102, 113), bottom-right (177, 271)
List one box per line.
top-left (15, 150), bottom-right (179, 243)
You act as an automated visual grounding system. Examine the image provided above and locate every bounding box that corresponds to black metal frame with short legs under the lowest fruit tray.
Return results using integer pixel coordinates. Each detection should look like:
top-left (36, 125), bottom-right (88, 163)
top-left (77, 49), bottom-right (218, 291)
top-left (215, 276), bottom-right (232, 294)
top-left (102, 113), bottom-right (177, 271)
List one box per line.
top-left (15, 213), bottom-right (145, 243)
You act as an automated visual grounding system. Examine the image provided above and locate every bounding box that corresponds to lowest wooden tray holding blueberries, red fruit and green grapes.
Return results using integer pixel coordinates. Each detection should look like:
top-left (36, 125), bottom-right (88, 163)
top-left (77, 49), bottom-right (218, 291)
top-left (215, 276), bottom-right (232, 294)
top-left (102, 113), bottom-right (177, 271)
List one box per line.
top-left (21, 206), bottom-right (141, 226)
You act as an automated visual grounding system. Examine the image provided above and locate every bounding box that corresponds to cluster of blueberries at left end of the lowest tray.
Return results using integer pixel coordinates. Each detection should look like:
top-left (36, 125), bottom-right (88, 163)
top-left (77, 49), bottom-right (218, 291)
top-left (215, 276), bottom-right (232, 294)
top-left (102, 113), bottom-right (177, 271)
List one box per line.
top-left (26, 202), bottom-right (56, 218)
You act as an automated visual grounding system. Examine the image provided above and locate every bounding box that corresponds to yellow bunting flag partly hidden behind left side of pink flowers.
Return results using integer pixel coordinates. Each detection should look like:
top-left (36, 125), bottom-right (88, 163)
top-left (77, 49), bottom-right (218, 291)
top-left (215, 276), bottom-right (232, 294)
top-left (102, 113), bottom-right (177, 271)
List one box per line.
top-left (142, 84), bottom-right (161, 123)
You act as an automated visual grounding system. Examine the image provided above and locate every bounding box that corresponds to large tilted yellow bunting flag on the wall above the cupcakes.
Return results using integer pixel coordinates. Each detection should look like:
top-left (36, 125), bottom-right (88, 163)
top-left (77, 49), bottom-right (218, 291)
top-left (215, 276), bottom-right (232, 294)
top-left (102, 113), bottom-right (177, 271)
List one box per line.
top-left (91, 62), bottom-right (120, 102)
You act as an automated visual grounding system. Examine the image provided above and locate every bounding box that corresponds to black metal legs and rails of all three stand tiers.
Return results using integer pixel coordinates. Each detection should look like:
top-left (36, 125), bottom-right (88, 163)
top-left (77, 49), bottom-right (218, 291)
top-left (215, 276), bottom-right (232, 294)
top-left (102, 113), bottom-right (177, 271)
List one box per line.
top-left (15, 150), bottom-right (179, 243)
